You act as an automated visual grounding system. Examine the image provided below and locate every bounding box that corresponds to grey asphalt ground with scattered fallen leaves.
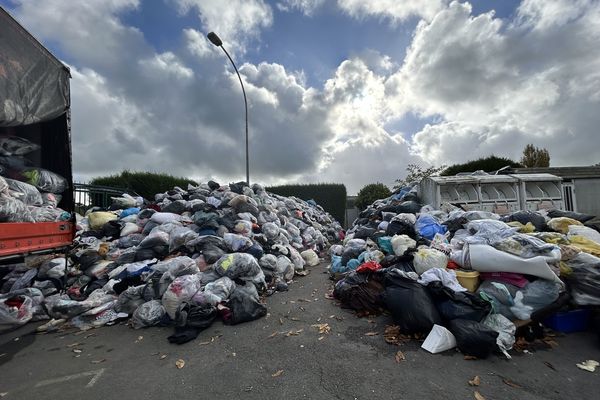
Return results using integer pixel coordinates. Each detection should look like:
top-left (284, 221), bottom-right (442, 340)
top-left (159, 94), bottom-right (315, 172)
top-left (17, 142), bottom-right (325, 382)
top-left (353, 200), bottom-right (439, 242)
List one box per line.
top-left (0, 265), bottom-right (600, 400)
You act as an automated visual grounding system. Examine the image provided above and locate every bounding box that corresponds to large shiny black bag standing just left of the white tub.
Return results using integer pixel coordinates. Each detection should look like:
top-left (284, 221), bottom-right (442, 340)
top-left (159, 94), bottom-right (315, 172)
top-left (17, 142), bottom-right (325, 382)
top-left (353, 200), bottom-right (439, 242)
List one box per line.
top-left (384, 270), bottom-right (442, 333)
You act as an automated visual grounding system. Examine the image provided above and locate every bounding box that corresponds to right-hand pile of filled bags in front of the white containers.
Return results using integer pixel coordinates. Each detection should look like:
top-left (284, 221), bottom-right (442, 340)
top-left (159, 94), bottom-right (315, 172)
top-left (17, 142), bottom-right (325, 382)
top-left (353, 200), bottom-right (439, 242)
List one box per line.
top-left (328, 188), bottom-right (600, 358)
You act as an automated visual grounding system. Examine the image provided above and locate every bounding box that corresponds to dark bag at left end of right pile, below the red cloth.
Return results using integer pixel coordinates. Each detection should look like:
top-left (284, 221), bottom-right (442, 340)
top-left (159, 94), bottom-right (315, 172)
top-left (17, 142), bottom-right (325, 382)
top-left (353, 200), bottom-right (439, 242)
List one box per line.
top-left (333, 271), bottom-right (385, 314)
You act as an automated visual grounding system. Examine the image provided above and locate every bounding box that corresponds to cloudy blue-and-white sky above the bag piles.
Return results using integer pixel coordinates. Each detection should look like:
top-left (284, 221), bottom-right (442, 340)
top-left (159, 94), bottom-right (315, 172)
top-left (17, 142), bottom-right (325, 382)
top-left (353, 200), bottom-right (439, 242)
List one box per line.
top-left (0, 0), bottom-right (600, 194)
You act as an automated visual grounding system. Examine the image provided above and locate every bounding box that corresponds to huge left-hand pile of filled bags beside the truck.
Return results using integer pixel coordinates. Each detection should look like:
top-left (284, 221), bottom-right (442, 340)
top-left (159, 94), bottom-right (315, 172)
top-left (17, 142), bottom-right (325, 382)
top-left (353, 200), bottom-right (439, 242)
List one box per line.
top-left (0, 181), bottom-right (343, 343)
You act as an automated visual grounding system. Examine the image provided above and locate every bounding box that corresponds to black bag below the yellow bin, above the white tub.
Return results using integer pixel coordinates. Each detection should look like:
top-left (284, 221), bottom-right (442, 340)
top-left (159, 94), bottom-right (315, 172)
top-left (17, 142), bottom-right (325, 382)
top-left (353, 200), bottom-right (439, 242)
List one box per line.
top-left (427, 282), bottom-right (492, 322)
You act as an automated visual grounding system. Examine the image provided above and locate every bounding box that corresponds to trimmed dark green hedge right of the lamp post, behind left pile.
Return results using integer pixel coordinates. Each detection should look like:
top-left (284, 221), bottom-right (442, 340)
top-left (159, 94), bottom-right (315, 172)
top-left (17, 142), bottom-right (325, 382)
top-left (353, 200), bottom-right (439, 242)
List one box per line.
top-left (265, 183), bottom-right (346, 224)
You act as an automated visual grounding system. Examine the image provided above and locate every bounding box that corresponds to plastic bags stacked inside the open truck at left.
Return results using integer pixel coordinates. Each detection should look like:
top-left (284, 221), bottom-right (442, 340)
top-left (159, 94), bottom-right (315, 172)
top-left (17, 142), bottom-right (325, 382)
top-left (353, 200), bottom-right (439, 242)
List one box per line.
top-left (0, 136), bottom-right (71, 222)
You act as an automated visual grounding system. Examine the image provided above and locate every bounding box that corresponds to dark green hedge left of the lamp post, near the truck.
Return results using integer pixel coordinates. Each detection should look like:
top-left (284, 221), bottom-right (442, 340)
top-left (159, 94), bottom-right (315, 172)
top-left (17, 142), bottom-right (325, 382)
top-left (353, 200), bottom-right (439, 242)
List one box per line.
top-left (90, 171), bottom-right (198, 201)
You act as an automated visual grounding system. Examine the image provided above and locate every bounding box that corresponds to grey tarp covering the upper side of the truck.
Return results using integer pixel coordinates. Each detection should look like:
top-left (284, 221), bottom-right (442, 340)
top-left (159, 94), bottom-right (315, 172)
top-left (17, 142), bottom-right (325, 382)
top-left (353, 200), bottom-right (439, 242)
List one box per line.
top-left (0, 7), bottom-right (70, 127)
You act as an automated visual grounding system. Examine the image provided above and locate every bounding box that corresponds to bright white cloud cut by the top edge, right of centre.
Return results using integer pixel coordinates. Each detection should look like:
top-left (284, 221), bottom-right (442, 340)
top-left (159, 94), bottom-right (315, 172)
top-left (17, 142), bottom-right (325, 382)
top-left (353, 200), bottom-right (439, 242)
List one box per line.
top-left (338, 0), bottom-right (448, 24)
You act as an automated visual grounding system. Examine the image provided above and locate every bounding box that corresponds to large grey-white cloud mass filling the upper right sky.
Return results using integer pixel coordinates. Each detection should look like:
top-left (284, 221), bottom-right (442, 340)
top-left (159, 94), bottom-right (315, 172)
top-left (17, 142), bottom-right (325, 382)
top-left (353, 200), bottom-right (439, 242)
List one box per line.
top-left (386, 0), bottom-right (600, 169)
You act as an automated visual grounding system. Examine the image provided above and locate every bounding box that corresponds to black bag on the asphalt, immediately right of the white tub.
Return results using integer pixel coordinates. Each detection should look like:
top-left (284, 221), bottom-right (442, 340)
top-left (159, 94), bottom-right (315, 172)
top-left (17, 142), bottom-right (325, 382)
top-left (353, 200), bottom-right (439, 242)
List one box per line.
top-left (448, 319), bottom-right (498, 358)
